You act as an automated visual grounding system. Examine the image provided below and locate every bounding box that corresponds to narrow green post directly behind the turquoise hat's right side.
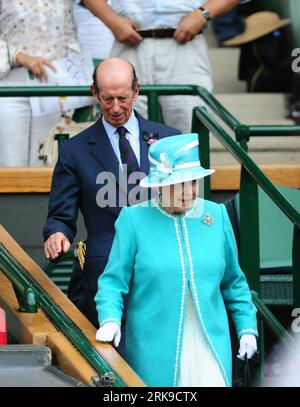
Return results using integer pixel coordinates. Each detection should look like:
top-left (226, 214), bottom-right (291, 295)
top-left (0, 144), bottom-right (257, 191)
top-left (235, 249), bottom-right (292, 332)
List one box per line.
top-left (192, 107), bottom-right (210, 199)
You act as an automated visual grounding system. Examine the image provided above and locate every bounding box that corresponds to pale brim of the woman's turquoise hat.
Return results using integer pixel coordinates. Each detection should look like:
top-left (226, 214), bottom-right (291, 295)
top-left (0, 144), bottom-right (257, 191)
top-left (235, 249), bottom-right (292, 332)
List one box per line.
top-left (140, 167), bottom-right (215, 188)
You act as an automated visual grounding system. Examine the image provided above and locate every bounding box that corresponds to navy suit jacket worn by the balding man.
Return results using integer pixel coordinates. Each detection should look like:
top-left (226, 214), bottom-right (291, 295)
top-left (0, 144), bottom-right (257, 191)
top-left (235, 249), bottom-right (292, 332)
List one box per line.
top-left (44, 112), bottom-right (180, 326)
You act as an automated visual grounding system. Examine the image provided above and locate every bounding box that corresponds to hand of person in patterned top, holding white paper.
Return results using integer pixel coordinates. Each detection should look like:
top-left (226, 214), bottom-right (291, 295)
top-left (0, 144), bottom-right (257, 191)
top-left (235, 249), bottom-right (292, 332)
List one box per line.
top-left (15, 51), bottom-right (57, 82)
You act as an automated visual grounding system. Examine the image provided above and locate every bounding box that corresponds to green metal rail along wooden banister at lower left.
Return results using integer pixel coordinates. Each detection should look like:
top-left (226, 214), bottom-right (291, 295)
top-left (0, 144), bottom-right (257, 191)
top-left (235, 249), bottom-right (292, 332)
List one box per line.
top-left (0, 244), bottom-right (126, 387)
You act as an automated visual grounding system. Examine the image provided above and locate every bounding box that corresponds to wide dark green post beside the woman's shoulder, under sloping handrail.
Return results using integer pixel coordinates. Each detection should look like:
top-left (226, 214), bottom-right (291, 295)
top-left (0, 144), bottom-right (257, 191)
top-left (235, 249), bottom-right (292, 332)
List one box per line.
top-left (240, 166), bottom-right (260, 295)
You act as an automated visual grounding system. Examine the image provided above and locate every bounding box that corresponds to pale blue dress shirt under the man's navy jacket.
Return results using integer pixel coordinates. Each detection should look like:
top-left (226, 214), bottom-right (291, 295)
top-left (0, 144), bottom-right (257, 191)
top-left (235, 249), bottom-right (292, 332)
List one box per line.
top-left (102, 112), bottom-right (140, 168)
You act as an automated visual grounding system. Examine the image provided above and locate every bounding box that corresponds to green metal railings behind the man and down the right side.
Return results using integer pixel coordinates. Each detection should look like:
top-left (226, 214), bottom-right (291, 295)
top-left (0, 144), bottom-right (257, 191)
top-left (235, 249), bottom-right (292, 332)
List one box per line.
top-left (0, 85), bottom-right (300, 386)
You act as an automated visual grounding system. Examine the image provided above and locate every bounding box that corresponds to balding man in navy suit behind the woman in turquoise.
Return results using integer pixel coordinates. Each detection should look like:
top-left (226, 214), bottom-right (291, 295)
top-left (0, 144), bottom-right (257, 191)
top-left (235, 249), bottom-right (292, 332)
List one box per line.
top-left (44, 58), bottom-right (180, 326)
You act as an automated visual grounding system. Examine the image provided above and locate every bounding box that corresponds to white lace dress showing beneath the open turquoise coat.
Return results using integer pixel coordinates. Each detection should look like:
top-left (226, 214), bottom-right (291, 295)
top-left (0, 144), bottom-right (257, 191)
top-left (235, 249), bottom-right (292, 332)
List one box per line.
top-left (178, 287), bottom-right (226, 387)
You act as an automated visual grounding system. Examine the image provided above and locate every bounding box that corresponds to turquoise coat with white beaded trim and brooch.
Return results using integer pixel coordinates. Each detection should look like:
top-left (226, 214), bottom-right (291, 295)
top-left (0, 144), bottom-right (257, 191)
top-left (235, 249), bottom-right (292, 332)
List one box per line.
top-left (95, 199), bottom-right (257, 386)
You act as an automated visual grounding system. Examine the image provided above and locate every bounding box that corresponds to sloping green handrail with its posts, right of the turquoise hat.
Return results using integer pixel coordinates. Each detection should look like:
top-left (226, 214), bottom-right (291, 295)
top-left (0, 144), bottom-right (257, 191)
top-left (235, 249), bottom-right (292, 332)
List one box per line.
top-left (192, 107), bottom-right (300, 377)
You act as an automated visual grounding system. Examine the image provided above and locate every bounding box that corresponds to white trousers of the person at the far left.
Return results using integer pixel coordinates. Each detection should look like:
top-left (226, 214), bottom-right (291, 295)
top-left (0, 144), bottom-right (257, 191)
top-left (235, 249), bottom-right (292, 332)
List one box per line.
top-left (0, 68), bottom-right (60, 167)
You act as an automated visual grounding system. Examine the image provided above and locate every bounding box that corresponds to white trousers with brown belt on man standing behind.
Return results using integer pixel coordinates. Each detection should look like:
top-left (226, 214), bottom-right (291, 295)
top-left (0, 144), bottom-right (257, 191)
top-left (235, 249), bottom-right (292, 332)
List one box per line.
top-left (111, 34), bottom-right (212, 133)
